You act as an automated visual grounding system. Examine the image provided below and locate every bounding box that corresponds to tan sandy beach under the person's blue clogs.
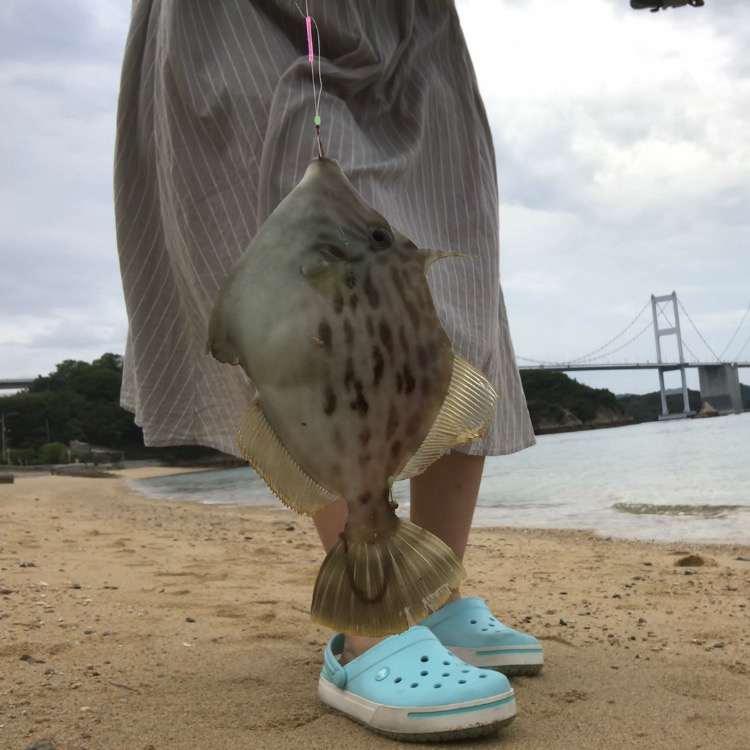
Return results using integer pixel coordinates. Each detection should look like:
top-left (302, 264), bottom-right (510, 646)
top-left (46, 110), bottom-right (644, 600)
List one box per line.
top-left (0, 469), bottom-right (750, 750)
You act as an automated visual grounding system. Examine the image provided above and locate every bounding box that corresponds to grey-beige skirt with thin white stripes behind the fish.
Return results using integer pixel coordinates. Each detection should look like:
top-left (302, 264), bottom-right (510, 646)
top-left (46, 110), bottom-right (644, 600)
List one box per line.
top-left (114, 0), bottom-right (534, 462)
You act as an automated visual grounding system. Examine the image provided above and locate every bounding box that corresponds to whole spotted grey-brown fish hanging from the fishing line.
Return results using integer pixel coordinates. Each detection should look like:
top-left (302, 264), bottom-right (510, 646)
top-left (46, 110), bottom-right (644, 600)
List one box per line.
top-left (207, 157), bottom-right (498, 636)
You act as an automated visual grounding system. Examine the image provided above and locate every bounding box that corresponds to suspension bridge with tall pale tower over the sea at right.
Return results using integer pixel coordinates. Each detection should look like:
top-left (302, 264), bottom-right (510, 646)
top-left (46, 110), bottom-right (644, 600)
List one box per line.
top-left (517, 292), bottom-right (750, 419)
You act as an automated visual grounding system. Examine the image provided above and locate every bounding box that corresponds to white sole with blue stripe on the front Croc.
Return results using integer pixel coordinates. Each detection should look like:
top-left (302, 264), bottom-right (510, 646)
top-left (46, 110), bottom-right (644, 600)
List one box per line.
top-left (318, 676), bottom-right (516, 742)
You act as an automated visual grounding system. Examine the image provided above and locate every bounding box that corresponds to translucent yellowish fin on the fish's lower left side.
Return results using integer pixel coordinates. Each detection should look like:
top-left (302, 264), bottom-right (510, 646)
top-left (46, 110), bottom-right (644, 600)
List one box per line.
top-left (237, 399), bottom-right (338, 516)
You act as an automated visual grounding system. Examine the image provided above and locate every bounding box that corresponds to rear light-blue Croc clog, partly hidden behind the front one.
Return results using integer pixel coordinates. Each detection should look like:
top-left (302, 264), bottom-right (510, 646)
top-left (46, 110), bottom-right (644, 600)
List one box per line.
top-left (420, 596), bottom-right (544, 677)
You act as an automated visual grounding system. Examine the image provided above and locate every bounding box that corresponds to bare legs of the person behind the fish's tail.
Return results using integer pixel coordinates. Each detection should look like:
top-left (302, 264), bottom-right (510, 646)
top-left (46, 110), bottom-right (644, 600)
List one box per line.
top-left (313, 453), bottom-right (484, 664)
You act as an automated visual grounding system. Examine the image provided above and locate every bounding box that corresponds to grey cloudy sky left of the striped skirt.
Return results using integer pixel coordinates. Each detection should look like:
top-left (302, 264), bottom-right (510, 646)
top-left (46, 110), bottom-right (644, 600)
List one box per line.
top-left (0, 0), bottom-right (128, 377)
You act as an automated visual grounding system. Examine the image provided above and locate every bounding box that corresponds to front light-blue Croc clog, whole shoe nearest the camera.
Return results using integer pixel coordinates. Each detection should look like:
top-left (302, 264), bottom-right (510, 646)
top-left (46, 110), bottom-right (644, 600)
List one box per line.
top-left (318, 626), bottom-right (516, 742)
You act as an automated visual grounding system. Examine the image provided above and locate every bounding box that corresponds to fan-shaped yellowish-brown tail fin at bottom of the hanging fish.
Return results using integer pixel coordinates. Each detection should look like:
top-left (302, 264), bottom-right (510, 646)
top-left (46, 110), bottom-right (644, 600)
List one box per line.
top-left (311, 519), bottom-right (466, 637)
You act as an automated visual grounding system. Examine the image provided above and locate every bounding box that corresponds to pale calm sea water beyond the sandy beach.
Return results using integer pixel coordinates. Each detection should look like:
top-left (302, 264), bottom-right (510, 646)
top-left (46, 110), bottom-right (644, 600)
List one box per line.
top-left (129, 412), bottom-right (750, 544)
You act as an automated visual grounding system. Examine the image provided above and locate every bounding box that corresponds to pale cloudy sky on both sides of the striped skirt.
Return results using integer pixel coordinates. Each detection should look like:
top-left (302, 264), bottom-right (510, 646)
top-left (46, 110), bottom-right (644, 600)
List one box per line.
top-left (0, 0), bottom-right (750, 393)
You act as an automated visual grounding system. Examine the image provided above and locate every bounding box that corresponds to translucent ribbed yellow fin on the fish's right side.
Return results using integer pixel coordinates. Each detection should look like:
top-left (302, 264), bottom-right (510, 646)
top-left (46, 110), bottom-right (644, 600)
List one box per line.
top-left (396, 355), bottom-right (498, 479)
